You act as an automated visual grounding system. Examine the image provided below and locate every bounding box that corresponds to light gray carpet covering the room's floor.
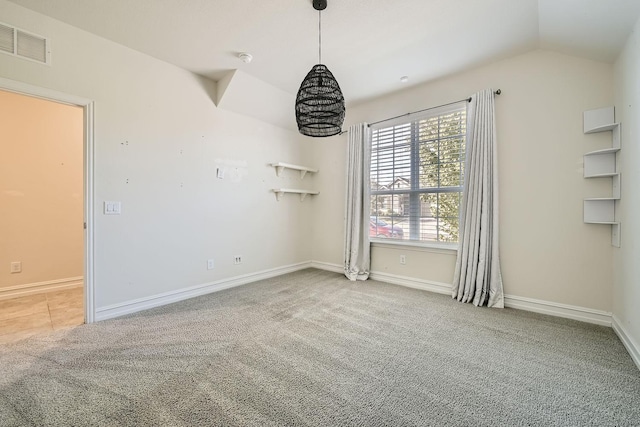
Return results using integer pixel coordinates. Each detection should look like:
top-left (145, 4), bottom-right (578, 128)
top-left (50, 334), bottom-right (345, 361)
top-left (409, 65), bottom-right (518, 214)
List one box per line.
top-left (0, 269), bottom-right (640, 426)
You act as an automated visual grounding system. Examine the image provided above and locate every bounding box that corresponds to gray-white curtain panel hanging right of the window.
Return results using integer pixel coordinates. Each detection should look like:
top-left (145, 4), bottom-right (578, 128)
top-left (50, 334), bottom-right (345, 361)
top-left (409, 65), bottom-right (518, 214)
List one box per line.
top-left (452, 89), bottom-right (504, 308)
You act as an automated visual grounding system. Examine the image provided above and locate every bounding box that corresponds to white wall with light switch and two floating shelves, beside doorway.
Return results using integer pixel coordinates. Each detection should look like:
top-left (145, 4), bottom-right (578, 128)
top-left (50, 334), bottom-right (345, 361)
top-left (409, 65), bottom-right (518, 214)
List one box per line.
top-left (0, 0), bottom-right (314, 309)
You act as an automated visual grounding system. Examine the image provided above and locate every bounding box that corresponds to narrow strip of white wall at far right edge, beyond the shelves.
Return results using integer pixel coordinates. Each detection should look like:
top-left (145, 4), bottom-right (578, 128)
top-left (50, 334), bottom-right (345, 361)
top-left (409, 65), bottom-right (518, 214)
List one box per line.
top-left (613, 16), bottom-right (640, 366)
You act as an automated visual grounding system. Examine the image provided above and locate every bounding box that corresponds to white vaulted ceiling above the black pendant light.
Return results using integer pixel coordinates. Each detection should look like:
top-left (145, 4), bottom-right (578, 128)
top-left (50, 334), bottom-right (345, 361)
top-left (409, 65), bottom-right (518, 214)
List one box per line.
top-left (10, 0), bottom-right (640, 104)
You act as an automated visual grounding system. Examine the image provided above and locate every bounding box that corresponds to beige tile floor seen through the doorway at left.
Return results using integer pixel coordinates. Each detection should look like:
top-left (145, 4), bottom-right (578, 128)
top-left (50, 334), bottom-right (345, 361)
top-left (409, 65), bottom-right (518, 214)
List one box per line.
top-left (0, 286), bottom-right (84, 344)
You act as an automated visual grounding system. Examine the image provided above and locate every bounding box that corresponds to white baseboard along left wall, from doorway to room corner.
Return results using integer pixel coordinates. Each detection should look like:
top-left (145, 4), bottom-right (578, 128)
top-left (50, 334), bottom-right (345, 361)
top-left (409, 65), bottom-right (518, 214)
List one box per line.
top-left (95, 261), bottom-right (311, 321)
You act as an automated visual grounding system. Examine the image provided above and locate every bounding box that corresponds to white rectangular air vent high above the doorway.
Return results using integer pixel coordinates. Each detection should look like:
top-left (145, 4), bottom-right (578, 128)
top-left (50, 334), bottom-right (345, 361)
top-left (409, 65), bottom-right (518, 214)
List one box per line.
top-left (0, 22), bottom-right (51, 64)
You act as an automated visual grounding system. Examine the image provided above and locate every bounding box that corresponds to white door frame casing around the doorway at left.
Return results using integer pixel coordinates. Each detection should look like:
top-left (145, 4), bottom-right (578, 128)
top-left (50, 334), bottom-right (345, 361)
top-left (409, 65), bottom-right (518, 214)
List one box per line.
top-left (0, 77), bottom-right (96, 323)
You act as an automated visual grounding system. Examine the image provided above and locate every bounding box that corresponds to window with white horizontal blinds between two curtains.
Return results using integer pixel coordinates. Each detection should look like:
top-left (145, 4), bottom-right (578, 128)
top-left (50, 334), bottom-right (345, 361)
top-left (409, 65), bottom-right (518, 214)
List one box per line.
top-left (369, 101), bottom-right (466, 242)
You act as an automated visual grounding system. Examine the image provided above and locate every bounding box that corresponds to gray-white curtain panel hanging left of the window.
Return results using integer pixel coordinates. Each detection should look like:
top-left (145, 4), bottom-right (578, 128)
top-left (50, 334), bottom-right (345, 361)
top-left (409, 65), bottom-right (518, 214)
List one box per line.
top-left (344, 123), bottom-right (371, 280)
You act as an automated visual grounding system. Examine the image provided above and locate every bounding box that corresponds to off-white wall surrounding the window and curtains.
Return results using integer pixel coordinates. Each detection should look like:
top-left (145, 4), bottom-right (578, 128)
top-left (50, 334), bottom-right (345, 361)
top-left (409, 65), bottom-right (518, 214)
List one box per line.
top-left (313, 51), bottom-right (613, 312)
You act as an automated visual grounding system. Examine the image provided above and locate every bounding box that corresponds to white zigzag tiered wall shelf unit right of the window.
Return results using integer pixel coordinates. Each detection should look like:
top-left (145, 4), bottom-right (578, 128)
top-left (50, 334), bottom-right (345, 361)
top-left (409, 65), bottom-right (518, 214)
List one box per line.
top-left (583, 107), bottom-right (620, 247)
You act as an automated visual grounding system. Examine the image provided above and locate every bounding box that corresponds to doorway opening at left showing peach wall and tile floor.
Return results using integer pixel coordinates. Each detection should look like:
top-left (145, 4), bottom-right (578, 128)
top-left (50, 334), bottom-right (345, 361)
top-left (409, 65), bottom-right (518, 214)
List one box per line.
top-left (0, 79), bottom-right (95, 341)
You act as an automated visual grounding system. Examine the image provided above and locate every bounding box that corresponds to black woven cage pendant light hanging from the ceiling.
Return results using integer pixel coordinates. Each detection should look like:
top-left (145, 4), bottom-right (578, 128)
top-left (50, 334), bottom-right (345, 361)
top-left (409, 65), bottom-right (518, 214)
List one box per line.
top-left (296, 0), bottom-right (344, 137)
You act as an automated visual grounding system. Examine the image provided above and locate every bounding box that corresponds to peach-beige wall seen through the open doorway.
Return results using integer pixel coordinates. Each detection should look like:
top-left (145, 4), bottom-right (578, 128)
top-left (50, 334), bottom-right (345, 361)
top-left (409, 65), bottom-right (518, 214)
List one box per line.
top-left (0, 91), bottom-right (84, 288)
